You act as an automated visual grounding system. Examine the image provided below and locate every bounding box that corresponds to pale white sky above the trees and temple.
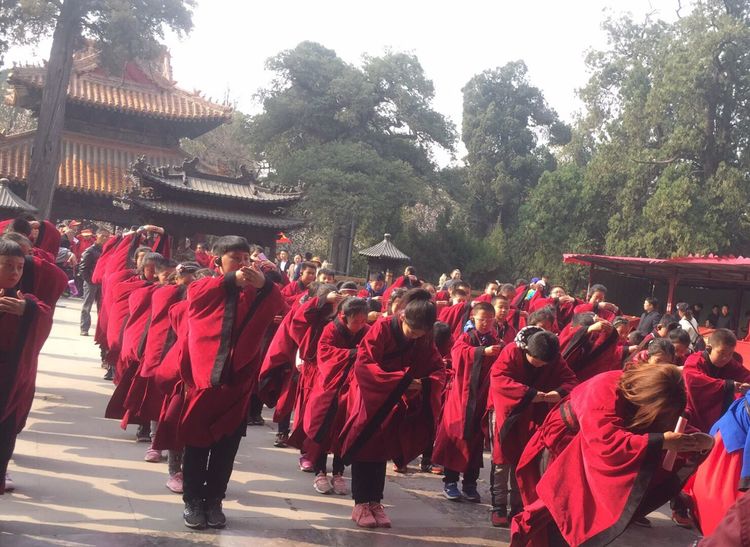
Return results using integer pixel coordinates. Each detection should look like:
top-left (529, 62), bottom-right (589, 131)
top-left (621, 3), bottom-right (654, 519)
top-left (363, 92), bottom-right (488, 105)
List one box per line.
top-left (6, 0), bottom-right (689, 163)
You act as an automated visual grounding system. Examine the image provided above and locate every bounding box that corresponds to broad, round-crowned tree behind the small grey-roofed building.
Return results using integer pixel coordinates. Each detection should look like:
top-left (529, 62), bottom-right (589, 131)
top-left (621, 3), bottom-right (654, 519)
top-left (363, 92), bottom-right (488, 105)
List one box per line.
top-left (250, 42), bottom-right (455, 269)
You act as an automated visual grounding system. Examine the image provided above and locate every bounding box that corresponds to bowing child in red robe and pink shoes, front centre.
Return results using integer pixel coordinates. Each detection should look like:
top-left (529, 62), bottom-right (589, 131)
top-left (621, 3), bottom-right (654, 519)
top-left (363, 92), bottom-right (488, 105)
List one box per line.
top-left (340, 289), bottom-right (445, 528)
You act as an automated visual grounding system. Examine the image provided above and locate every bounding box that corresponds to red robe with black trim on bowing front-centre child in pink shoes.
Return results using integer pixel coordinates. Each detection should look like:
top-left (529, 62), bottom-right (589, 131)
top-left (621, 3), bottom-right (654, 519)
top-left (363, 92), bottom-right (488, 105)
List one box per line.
top-left (340, 316), bottom-right (445, 462)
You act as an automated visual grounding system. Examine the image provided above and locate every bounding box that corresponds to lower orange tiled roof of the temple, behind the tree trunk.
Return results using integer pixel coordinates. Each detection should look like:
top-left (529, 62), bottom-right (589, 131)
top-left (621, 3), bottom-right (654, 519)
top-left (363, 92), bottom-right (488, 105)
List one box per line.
top-left (0, 131), bottom-right (184, 195)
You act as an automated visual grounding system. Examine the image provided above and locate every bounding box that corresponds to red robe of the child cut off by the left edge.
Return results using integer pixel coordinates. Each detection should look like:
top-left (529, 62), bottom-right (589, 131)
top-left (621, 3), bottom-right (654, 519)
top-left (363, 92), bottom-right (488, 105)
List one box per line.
top-left (0, 291), bottom-right (52, 436)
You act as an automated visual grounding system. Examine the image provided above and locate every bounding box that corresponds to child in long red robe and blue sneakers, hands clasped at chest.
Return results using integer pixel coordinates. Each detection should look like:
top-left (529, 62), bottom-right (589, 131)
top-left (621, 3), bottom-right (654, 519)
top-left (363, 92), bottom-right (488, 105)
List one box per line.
top-left (432, 302), bottom-right (502, 503)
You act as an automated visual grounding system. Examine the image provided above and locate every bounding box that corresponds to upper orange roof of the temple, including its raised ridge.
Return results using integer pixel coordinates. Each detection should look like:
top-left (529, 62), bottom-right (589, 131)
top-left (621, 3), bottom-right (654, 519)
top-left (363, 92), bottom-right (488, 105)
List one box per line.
top-left (8, 46), bottom-right (232, 126)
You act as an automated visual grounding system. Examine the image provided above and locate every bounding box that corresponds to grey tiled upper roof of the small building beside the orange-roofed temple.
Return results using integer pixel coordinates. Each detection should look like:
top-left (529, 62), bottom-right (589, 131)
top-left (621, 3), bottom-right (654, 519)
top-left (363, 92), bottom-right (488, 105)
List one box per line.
top-left (132, 158), bottom-right (302, 205)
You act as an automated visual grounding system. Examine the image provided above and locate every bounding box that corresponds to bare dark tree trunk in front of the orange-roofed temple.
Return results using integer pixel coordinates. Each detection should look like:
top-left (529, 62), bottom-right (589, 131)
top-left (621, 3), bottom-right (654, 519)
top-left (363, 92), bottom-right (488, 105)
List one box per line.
top-left (27, 0), bottom-right (81, 218)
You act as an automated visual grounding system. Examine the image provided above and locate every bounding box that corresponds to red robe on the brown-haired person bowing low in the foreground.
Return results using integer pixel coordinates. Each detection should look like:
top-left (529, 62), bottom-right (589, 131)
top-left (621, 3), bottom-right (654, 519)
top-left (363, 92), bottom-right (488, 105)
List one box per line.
top-left (511, 371), bottom-right (697, 547)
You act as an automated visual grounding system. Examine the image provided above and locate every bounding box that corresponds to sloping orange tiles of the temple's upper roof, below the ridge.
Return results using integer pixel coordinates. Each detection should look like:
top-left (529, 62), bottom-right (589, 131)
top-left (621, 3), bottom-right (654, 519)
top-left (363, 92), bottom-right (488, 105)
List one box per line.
top-left (8, 66), bottom-right (232, 123)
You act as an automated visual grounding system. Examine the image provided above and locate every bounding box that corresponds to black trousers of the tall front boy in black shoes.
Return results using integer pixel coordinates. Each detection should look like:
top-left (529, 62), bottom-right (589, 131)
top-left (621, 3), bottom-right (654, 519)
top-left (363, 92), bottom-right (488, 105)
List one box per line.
top-left (182, 423), bottom-right (246, 502)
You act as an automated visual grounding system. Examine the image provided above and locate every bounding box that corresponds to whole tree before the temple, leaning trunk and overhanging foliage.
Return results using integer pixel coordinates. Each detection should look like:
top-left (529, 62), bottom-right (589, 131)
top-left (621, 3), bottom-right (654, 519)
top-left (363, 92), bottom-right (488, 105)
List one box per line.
top-left (0, 0), bottom-right (193, 216)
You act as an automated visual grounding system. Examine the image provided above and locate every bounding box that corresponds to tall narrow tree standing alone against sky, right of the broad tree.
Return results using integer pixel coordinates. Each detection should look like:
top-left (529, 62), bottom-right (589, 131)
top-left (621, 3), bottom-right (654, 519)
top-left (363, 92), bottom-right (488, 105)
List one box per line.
top-left (462, 61), bottom-right (570, 235)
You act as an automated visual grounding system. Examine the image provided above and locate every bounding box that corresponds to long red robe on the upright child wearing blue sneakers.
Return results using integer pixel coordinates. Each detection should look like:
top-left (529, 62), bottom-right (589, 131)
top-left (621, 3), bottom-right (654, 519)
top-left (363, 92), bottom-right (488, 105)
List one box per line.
top-left (432, 329), bottom-right (502, 473)
